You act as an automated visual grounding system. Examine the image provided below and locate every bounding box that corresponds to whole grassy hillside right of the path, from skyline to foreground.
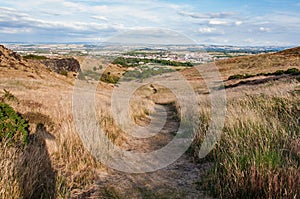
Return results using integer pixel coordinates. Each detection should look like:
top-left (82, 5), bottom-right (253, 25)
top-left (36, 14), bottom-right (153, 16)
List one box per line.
top-left (189, 48), bottom-right (300, 198)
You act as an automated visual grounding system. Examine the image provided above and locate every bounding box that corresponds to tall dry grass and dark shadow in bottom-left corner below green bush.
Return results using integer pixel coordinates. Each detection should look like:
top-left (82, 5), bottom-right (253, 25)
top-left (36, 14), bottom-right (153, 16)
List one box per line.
top-left (0, 125), bottom-right (55, 199)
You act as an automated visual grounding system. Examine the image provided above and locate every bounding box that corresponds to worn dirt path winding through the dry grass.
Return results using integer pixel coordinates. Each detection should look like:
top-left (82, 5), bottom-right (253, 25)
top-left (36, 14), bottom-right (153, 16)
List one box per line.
top-left (74, 100), bottom-right (211, 198)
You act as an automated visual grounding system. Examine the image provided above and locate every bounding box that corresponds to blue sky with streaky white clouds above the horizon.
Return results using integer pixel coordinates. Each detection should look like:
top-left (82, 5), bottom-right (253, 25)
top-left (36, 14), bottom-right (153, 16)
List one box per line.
top-left (0, 0), bottom-right (300, 46)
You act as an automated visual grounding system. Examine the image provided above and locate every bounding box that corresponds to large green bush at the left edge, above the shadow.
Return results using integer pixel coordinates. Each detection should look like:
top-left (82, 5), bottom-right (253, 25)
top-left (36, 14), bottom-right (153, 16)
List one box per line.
top-left (0, 102), bottom-right (28, 145)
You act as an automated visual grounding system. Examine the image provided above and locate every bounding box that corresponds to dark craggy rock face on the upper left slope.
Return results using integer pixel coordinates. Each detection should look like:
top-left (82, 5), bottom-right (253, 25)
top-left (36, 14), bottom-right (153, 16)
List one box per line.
top-left (41, 58), bottom-right (80, 73)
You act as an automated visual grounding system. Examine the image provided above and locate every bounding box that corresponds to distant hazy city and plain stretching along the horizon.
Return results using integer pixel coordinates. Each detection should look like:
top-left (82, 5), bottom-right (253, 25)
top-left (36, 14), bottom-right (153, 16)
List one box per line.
top-left (5, 43), bottom-right (288, 63)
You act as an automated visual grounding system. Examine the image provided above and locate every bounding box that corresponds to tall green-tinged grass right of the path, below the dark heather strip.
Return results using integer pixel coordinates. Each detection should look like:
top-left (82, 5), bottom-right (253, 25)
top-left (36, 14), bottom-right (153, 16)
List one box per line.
top-left (199, 94), bottom-right (300, 198)
